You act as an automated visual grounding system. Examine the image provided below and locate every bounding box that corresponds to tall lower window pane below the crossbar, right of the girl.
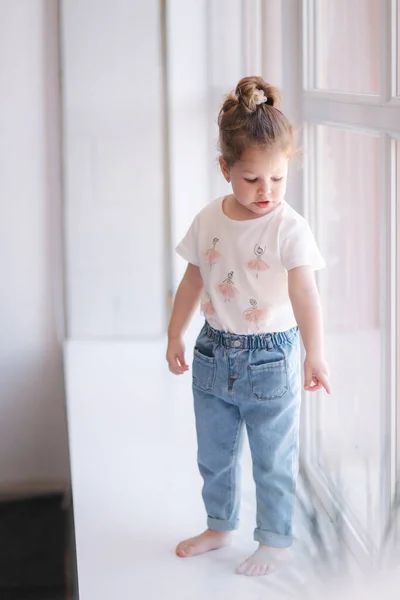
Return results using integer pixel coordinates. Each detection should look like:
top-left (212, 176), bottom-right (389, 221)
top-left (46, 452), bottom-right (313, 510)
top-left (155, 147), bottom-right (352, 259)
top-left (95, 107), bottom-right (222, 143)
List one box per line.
top-left (312, 126), bottom-right (384, 530)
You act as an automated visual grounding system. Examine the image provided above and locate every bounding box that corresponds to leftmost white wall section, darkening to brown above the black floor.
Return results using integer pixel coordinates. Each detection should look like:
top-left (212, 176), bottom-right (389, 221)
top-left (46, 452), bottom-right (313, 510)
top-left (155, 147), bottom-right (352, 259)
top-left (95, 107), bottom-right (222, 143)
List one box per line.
top-left (0, 0), bottom-right (69, 490)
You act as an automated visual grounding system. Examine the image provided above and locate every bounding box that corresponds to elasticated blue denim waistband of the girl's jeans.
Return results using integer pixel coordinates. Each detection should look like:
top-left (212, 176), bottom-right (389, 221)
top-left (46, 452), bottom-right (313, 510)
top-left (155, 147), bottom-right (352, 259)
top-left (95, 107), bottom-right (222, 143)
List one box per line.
top-left (204, 322), bottom-right (299, 350)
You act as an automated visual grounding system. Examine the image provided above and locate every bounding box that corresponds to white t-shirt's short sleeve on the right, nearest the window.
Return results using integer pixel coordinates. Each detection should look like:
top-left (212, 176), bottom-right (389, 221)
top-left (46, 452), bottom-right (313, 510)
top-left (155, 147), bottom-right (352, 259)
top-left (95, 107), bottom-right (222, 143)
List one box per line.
top-left (280, 218), bottom-right (326, 271)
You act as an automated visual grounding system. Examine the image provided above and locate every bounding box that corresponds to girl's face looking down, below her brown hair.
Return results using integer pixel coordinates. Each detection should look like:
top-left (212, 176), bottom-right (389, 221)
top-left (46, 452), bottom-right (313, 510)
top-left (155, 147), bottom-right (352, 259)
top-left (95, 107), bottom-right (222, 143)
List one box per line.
top-left (220, 148), bottom-right (289, 217)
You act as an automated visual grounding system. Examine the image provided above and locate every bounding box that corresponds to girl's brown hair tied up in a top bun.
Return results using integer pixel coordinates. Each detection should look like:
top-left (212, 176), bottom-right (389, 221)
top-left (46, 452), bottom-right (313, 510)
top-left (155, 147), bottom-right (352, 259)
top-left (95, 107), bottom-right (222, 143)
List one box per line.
top-left (218, 76), bottom-right (294, 167)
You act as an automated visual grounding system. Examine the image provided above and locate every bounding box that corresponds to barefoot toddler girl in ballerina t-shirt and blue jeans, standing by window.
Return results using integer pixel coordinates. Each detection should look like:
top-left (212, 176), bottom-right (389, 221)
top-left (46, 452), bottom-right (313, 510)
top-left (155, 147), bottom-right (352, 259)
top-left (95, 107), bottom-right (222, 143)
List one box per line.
top-left (167, 77), bottom-right (330, 575)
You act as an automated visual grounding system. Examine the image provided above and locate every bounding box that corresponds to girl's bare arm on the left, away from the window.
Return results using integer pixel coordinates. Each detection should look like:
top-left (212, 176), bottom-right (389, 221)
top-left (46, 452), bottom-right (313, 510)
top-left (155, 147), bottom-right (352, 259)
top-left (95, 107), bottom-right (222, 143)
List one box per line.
top-left (167, 263), bottom-right (204, 375)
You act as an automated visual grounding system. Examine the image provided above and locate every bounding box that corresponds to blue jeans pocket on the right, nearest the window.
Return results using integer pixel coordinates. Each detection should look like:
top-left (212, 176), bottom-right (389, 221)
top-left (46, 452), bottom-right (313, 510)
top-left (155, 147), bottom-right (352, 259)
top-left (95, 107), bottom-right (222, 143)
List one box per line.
top-left (248, 359), bottom-right (288, 400)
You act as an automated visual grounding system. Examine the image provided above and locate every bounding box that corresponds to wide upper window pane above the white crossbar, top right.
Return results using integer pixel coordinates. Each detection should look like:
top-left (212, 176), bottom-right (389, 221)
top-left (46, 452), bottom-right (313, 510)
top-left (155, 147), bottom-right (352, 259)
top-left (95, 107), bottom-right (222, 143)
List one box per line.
top-left (310, 0), bottom-right (380, 94)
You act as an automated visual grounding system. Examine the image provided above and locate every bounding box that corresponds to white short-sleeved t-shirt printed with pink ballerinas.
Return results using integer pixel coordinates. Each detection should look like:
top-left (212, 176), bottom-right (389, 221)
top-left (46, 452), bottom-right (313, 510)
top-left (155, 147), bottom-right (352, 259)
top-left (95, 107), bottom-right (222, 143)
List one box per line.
top-left (176, 198), bottom-right (325, 335)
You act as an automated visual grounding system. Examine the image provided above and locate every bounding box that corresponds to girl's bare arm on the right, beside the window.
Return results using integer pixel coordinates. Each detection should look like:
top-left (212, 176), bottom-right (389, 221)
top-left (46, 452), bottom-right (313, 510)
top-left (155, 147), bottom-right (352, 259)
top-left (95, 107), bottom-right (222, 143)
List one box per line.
top-left (288, 267), bottom-right (331, 394)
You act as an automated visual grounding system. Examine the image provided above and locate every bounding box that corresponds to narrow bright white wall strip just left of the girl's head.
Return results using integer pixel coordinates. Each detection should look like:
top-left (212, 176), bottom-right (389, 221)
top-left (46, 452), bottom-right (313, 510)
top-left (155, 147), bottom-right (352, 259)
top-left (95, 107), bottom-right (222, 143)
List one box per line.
top-left (166, 0), bottom-right (211, 291)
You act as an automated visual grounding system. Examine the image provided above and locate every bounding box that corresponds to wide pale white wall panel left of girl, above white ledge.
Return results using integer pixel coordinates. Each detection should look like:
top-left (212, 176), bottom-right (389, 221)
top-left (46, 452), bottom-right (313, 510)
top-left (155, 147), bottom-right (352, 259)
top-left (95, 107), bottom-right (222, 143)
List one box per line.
top-left (62, 0), bottom-right (167, 339)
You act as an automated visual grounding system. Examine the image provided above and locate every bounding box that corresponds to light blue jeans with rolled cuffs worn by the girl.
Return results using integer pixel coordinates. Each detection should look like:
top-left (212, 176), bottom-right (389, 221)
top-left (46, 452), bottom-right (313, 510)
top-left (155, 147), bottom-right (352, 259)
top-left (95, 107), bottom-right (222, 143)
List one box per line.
top-left (193, 323), bottom-right (301, 548)
